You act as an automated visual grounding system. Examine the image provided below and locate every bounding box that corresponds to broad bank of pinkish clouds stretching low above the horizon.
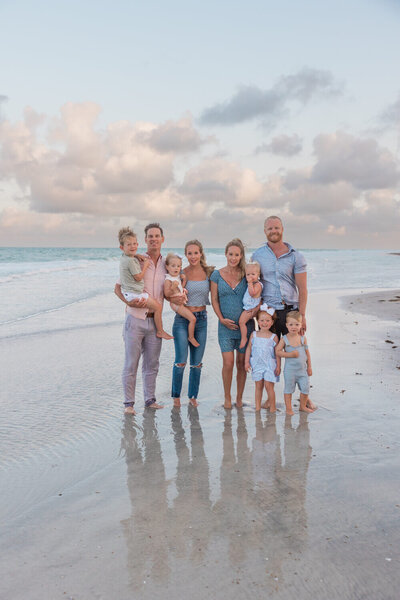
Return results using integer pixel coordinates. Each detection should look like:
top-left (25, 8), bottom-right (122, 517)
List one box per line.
top-left (0, 104), bottom-right (400, 247)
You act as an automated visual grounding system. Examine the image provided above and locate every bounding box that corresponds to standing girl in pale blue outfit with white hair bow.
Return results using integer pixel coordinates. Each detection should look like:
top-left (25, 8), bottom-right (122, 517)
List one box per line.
top-left (244, 304), bottom-right (281, 412)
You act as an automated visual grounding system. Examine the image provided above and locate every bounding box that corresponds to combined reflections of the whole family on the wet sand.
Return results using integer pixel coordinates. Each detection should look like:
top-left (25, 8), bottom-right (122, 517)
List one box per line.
top-left (122, 406), bottom-right (311, 592)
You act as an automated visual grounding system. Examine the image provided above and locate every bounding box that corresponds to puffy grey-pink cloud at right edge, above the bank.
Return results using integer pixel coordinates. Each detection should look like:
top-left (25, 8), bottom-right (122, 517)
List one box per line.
top-left (311, 131), bottom-right (400, 190)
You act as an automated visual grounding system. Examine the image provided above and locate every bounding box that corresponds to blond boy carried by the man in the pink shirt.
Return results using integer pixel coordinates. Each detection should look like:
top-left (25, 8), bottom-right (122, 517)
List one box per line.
top-left (118, 227), bottom-right (172, 340)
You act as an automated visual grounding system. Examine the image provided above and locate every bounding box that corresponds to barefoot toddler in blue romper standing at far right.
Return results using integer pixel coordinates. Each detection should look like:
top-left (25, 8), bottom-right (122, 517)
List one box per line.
top-left (276, 310), bottom-right (314, 415)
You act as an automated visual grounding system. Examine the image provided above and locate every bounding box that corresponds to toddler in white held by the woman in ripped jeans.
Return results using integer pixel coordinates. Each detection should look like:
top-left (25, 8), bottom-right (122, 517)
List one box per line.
top-left (164, 252), bottom-right (200, 348)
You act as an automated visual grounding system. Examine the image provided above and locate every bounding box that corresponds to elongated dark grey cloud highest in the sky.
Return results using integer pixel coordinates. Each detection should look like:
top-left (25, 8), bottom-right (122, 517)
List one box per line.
top-left (200, 68), bottom-right (340, 125)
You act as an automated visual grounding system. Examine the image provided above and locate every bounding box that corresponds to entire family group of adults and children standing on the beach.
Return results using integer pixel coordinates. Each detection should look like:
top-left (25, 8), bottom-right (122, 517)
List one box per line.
top-left (114, 216), bottom-right (316, 415)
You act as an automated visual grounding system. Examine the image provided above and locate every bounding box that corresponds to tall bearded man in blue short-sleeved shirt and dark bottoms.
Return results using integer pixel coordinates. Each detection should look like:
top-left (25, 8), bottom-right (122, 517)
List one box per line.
top-left (252, 216), bottom-right (307, 337)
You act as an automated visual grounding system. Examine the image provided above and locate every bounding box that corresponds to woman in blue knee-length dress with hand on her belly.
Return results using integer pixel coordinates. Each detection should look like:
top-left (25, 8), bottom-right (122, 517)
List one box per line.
top-left (210, 238), bottom-right (254, 408)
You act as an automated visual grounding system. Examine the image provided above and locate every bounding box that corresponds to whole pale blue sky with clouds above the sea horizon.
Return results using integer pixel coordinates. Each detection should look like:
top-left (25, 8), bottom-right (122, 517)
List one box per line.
top-left (0, 0), bottom-right (400, 249)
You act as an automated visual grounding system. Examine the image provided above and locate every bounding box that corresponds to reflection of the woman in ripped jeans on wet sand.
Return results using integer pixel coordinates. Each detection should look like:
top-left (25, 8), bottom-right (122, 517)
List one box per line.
top-left (169, 405), bottom-right (212, 564)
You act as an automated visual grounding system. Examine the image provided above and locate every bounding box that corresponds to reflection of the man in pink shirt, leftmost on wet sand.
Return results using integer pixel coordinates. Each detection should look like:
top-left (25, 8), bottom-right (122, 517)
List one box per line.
top-left (121, 409), bottom-right (170, 591)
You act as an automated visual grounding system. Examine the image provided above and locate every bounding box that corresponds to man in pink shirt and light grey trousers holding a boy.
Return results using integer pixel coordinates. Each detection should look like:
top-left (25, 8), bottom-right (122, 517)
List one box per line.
top-left (114, 223), bottom-right (178, 415)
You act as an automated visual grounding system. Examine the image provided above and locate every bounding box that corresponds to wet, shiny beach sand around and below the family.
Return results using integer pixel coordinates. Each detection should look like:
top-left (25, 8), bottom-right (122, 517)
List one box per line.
top-left (0, 291), bottom-right (400, 600)
